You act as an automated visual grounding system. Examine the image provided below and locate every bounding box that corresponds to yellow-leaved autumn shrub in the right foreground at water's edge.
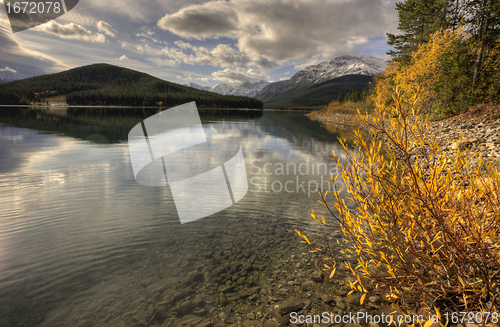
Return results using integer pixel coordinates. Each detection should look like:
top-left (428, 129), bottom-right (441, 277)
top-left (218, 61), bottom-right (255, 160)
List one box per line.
top-left (297, 89), bottom-right (500, 314)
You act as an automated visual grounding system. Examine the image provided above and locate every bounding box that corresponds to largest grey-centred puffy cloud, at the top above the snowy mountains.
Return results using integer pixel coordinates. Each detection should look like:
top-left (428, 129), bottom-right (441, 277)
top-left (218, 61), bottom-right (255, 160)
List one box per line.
top-left (158, 0), bottom-right (397, 62)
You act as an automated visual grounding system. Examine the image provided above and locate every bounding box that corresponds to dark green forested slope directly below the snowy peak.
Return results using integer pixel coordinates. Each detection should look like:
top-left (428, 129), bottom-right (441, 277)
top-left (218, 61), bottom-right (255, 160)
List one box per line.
top-left (264, 75), bottom-right (373, 110)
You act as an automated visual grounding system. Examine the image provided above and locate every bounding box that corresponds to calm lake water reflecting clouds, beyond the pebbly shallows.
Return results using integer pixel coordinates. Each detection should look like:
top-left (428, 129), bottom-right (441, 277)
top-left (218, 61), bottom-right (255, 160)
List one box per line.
top-left (0, 107), bottom-right (356, 326)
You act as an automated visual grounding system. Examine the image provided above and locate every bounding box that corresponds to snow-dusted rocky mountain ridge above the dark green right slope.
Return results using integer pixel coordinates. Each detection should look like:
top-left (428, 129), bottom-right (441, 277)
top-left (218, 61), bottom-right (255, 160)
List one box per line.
top-left (256, 55), bottom-right (387, 101)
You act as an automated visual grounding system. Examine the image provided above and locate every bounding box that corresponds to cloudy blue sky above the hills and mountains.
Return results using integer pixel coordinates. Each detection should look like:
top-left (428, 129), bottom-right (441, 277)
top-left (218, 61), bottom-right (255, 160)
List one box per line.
top-left (0, 0), bottom-right (398, 86)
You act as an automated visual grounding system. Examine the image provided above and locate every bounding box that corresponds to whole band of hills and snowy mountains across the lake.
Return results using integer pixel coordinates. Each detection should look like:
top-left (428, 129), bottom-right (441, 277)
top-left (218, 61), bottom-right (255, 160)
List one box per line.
top-left (0, 56), bottom-right (386, 109)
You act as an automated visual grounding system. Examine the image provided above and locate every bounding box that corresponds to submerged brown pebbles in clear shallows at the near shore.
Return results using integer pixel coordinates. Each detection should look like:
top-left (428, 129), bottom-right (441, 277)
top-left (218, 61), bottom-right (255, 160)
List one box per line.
top-left (40, 213), bottom-right (397, 327)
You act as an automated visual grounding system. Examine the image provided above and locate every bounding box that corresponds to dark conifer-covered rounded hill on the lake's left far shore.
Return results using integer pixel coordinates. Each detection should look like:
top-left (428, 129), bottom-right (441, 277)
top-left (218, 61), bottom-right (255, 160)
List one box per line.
top-left (0, 64), bottom-right (263, 109)
